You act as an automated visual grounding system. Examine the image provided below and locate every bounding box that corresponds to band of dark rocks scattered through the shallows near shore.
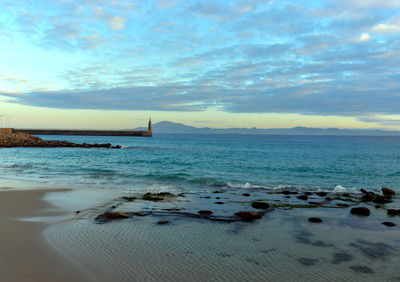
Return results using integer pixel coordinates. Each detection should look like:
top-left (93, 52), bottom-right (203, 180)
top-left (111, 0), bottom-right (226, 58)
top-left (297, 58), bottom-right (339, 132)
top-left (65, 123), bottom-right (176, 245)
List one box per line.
top-left (86, 188), bottom-right (400, 227)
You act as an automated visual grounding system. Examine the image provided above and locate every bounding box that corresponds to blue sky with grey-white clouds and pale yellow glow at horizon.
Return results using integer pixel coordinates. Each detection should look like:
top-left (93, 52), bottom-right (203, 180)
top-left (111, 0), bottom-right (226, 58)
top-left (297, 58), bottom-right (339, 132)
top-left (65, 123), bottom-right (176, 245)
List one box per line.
top-left (0, 0), bottom-right (400, 130)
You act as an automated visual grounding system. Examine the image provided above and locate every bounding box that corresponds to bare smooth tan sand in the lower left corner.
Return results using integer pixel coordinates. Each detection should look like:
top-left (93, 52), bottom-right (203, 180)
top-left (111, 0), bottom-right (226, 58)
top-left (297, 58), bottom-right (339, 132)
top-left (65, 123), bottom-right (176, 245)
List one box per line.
top-left (0, 189), bottom-right (93, 282)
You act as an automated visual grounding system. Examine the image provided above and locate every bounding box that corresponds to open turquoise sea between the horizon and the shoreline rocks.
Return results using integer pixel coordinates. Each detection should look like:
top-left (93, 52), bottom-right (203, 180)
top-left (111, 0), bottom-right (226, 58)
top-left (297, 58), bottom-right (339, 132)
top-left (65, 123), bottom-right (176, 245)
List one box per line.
top-left (0, 134), bottom-right (400, 191)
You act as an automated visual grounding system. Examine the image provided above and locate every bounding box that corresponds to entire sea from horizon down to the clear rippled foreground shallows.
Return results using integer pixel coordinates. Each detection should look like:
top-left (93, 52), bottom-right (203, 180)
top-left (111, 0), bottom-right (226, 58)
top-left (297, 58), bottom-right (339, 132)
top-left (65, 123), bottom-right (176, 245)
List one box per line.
top-left (0, 133), bottom-right (400, 281)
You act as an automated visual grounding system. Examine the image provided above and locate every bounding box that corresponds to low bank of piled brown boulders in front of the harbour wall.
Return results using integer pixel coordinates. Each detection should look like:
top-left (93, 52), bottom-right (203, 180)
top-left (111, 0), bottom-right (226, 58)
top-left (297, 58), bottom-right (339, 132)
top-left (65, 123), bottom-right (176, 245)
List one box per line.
top-left (0, 128), bottom-right (121, 149)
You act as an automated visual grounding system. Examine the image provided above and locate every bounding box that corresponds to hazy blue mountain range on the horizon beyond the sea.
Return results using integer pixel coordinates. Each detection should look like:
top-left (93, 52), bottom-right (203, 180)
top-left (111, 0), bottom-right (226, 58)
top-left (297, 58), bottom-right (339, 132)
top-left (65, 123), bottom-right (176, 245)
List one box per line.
top-left (135, 121), bottom-right (400, 136)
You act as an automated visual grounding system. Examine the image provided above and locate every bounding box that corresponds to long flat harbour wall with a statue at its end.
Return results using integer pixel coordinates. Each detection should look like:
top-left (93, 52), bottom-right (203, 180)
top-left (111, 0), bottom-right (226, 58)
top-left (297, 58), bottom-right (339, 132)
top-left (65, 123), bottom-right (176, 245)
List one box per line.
top-left (16, 119), bottom-right (153, 137)
